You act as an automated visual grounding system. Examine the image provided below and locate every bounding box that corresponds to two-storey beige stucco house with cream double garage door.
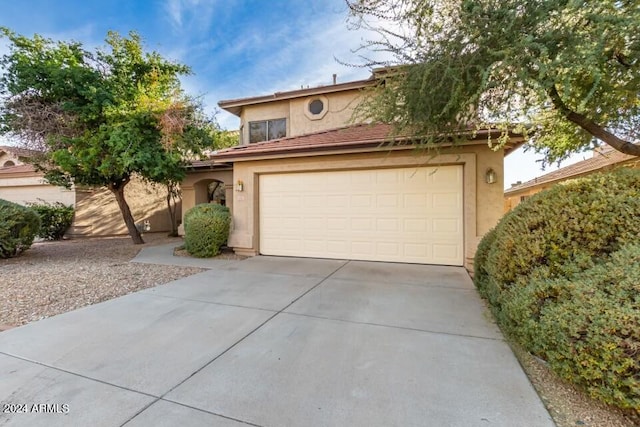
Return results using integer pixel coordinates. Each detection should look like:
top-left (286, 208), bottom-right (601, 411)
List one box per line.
top-left (182, 74), bottom-right (521, 267)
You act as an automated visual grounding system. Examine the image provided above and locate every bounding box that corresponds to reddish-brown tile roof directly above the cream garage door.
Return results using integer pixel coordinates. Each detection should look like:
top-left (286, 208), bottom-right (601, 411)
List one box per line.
top-left (211, 124), bottom-right (520, 161)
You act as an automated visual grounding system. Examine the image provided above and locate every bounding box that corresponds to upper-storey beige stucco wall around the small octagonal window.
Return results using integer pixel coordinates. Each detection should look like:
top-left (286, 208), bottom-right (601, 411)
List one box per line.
top-left (240, 90), bottom-right (360, 143)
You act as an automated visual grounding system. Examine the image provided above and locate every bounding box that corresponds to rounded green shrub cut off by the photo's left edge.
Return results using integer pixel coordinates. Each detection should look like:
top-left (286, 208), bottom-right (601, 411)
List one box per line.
top-left (0, 199), bottom-right (40, 258)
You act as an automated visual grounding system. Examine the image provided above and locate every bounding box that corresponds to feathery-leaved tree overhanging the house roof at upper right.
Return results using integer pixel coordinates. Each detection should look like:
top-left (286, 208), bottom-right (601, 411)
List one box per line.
top-left (346, 0), bottom-right (640, 162)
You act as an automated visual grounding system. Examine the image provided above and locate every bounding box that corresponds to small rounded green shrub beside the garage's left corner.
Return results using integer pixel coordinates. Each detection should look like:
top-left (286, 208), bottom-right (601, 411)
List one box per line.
top-left (184, 203), bottom-right (231, 258)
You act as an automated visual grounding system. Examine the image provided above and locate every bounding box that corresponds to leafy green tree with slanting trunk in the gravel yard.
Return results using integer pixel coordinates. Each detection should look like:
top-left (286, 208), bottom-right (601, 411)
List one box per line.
top-left (0, 28), bottom-right (212, 244)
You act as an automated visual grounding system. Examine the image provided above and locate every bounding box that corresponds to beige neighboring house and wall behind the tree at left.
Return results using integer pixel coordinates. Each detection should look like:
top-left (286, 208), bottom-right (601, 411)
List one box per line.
top-left (0, 146), bottom-right (180, 237)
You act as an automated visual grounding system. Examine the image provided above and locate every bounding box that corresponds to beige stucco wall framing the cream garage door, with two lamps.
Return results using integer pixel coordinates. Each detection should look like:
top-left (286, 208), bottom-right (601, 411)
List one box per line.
top-left (229, 145), bottom-right (504, 267)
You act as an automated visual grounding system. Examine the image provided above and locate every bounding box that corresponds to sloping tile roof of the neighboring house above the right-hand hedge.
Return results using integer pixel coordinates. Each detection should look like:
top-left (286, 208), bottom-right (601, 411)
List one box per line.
top-left (504, 148), bottom-right (640, 195)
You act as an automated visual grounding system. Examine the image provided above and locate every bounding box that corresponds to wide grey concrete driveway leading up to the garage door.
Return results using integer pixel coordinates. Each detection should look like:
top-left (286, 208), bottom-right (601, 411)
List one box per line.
top-left (0, 253), bottom-right (553, 427)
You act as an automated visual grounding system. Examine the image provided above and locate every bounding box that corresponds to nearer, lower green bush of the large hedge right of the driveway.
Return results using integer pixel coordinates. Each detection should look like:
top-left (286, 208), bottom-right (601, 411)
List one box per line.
top-left (503, 243), bottom-right (640, 412)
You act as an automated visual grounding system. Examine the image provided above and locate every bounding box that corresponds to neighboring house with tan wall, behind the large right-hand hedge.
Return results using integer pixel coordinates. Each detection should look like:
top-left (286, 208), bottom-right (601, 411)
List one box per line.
top-left (504, 145), bottom-right (640, 212)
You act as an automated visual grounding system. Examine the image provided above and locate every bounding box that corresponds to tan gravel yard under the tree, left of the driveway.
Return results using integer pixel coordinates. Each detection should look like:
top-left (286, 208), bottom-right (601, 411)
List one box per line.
top-left (0, 233), bottom-right (204, 330)
